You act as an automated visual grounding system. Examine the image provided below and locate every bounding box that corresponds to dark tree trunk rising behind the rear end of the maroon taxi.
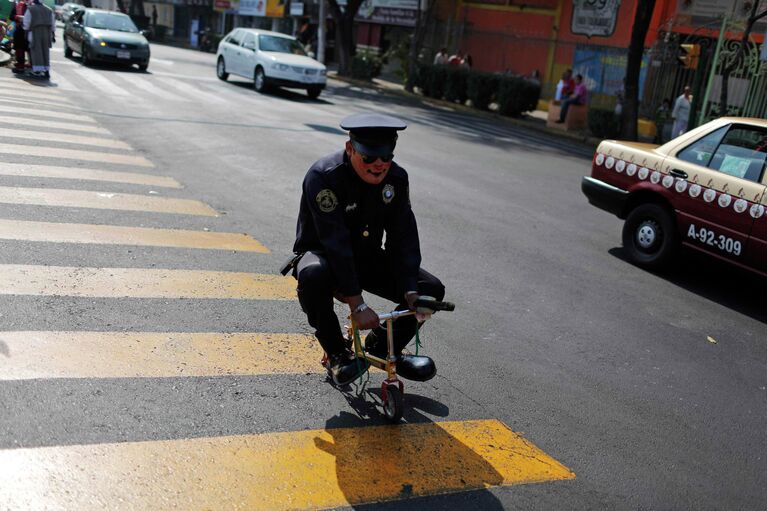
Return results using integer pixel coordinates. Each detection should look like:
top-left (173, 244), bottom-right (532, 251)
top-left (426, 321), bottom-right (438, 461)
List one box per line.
top-left (621, 0), bottom-right (655, 140)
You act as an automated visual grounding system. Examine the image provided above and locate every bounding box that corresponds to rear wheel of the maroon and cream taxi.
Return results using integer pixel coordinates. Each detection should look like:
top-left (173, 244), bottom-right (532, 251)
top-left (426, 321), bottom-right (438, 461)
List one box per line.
top-left (623, 204), bottom-right (679, 269)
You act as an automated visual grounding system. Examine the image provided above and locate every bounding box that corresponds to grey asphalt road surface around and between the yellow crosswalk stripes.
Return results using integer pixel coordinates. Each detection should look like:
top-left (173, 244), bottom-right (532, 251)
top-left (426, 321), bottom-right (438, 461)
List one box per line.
top-left (0, 30), bottom-right (767, 510)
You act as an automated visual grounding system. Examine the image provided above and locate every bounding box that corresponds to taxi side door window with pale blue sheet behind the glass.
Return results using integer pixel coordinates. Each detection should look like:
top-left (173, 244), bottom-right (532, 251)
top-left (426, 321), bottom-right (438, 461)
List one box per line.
top-left (709, 126), bottom-right (767, 182)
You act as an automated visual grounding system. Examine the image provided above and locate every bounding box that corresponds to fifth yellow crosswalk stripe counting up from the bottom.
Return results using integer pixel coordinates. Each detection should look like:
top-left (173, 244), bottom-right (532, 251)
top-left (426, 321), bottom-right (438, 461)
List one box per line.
top-left (0, 186), bottom-right (218, 216)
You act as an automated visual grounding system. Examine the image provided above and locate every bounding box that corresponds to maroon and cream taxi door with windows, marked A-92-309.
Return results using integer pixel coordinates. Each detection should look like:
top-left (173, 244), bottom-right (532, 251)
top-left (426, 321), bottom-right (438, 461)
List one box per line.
top-left (663, 124), bottom-right (767, 265)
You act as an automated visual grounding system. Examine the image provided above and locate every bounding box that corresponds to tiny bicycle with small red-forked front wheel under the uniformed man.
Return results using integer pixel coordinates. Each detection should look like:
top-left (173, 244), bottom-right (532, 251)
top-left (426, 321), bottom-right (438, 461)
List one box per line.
top-left (322, 296), bottom-right (455, 422)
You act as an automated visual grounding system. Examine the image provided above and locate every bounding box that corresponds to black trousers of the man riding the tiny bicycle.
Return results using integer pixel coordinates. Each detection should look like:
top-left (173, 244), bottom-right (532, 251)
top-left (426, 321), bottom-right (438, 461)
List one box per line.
top-left (294, 251), bottom-right (445, 355)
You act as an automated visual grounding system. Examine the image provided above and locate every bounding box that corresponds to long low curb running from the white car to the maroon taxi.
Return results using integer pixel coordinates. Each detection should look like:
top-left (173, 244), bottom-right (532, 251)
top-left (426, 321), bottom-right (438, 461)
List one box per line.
top-left (328, 72), bottom-right (602, 150)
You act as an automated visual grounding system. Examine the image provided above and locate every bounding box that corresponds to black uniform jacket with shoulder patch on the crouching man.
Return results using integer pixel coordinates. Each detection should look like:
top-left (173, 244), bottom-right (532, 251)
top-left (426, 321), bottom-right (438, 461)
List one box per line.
top-left (293, 151), bottom-right (421, 296)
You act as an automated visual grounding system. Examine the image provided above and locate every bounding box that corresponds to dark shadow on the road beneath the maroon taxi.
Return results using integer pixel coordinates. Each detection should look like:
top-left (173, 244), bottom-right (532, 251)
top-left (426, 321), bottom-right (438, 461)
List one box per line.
top-left (608, 247), bottom-right (767, 323)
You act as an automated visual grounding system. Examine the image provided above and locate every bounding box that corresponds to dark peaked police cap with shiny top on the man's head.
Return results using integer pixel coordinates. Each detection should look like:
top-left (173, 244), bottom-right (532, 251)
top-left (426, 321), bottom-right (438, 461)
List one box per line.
top-left (341, 114), bottom-right (407, 156)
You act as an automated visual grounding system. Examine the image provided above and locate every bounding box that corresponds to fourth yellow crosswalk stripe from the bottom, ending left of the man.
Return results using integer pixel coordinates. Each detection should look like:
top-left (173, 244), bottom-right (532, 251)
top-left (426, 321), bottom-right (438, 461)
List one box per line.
top-left (0, 219), bottom-right (269, 254)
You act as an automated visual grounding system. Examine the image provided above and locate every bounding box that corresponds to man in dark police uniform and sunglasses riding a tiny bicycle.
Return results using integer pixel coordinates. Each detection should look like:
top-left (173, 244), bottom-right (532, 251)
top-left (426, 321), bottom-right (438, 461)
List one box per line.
top-left (293, 114), bottom-right (445, 385)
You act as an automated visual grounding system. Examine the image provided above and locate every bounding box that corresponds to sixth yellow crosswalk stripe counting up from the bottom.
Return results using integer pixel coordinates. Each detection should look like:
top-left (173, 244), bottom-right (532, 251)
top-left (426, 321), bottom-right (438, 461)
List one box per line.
top-left (0, 163), bottom-right (181, 188)
